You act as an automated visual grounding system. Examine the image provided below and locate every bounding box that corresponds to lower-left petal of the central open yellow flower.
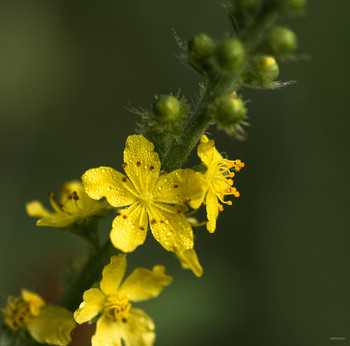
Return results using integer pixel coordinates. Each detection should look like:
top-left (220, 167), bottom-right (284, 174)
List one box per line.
top-left (110, 203), bottom-right (148, 252)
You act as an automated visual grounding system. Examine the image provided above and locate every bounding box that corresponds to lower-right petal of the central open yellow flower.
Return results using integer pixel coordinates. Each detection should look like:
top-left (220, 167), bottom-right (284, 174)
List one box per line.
top-left (148, 203), bottom-right (193, 252)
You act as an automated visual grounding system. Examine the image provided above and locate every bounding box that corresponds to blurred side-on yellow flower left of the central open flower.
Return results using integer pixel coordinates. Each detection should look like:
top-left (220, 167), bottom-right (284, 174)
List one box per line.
top-left (26, 181), bottom-right (108, 227)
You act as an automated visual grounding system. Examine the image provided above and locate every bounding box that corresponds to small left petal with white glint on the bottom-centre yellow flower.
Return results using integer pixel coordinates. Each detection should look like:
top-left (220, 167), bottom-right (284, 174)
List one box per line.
top-left (73, 288), bottom-right (105, 324)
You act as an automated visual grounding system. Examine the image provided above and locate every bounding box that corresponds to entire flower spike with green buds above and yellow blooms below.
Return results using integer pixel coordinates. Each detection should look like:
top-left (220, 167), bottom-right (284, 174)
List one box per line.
top-left (0, 0), bottom-right (305, 340)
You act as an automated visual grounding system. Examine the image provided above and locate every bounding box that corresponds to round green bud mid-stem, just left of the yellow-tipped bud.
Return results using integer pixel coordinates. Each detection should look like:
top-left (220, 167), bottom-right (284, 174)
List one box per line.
top-left (216, 40), bottom-right (245, 72)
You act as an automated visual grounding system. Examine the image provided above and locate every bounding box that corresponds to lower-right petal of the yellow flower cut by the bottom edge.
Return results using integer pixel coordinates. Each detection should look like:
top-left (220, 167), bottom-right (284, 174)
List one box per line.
top-left (120, 308), bottom-right (156, 346)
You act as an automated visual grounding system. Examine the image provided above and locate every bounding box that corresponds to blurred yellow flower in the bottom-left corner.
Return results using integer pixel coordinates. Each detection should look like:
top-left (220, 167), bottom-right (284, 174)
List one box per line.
top-left (2, 289), bottom-right (76, 345)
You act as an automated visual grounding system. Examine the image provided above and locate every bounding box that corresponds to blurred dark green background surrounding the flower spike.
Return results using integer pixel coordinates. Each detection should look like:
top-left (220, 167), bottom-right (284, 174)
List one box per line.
top-left (0, 0), bottom-right (350, 346)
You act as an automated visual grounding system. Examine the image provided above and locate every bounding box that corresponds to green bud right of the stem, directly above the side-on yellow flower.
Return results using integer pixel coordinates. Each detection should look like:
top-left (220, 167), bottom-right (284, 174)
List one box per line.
top-left (215, 95), bottom-right (247, 127)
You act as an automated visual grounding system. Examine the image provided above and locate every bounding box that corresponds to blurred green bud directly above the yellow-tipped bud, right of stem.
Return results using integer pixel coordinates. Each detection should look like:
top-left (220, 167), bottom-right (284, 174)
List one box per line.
top-left (269, 26), bottom-right (298, 55)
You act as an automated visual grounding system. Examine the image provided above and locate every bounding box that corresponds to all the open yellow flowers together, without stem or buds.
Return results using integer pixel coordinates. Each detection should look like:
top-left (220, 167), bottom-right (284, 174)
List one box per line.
top-left (3, 135), bottom-right (244, 346)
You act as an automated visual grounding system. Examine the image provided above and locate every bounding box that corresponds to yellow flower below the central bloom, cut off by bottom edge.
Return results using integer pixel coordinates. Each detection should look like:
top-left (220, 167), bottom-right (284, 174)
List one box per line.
top-left (74, 255), bottom-right (172, 346)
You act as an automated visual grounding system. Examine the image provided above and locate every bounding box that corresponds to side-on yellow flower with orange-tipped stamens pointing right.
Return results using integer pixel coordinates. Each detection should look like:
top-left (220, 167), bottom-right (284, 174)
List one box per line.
top-left (198, 135), bottom-right (244, 233)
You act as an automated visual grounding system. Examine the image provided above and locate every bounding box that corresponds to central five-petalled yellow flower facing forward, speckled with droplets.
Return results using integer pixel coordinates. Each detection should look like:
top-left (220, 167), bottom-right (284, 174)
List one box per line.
top-left (82, 135), bottom-right (204, 252)
